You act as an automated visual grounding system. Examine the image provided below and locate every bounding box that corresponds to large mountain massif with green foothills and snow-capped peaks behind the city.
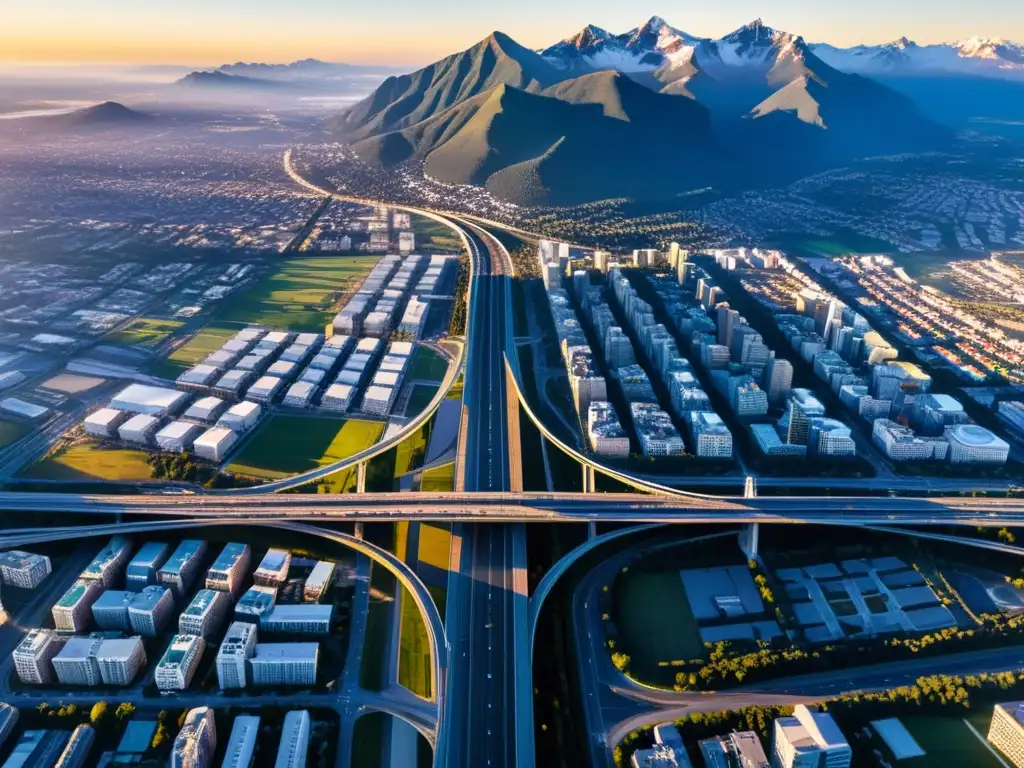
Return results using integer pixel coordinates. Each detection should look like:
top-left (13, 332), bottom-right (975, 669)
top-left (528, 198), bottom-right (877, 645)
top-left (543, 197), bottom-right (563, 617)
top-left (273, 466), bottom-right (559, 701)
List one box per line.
top-left (329, 16), bottom-right (952, 205)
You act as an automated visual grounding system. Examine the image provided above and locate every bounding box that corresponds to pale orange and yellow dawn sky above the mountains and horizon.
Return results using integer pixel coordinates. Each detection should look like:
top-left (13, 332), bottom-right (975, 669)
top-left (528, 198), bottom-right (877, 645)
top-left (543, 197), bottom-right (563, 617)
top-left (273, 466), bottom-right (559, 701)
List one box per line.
top-left (0, 0), bottom-right (1024, 66)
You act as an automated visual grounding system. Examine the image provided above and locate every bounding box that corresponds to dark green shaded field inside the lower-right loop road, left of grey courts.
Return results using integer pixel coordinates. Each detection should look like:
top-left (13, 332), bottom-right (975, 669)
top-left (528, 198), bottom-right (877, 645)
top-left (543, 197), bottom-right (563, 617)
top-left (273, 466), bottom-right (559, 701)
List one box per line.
top-left (612, 569), bottom-right (705, 684)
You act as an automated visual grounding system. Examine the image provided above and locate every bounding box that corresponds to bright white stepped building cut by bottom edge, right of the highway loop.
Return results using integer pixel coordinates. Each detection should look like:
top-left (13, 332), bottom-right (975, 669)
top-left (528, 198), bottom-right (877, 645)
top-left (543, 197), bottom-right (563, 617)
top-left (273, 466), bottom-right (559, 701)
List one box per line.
top-left (772, 705), bottom-right (853, 768)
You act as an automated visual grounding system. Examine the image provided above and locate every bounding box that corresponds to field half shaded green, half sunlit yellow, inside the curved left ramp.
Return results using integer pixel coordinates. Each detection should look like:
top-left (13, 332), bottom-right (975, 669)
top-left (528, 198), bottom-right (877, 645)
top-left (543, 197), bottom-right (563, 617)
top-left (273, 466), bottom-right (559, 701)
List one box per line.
top-left (227, 416), bottom-right (384, 480)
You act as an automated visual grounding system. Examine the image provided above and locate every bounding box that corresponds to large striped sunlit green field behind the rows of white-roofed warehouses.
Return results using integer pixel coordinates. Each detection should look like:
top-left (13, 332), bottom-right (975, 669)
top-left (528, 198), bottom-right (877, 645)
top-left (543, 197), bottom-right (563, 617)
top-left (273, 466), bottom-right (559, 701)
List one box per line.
top-left (219, 256), bottom-right (379, 332)
